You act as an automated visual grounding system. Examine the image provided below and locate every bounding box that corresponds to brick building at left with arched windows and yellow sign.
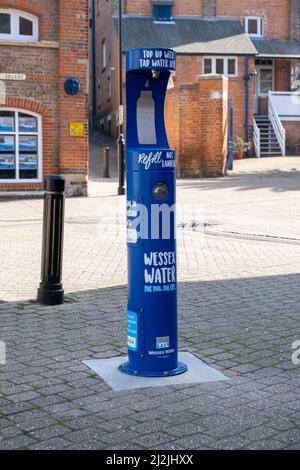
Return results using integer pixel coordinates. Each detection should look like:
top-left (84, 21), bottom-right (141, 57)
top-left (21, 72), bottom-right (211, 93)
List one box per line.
top-left (0, 0), bottom-right (88, 194)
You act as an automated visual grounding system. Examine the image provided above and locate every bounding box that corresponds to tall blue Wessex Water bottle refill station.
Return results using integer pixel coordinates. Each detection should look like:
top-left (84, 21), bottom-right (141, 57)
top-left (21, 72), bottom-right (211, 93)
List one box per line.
top-left (120, 49), bottom-right (187, 377)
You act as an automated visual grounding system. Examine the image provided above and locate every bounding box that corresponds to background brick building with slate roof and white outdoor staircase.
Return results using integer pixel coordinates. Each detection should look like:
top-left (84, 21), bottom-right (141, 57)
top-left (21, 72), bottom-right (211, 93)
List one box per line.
top-left (94, 0), bottom-right (300, 173)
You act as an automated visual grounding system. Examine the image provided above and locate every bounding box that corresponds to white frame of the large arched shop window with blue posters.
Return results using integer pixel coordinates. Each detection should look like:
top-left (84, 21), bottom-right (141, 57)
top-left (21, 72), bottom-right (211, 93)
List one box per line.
top-left (0, 107), bottom-right (43, 185)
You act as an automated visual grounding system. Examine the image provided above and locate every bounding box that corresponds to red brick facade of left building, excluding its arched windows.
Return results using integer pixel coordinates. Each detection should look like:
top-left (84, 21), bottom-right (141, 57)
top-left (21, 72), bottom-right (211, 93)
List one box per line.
top-left (0, 0), bottom-right (88, 194)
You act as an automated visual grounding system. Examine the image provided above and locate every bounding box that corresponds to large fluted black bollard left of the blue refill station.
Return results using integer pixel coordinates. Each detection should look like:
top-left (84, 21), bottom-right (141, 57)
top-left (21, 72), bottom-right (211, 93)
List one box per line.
top-left (37, 175), bottom-right (65, 305)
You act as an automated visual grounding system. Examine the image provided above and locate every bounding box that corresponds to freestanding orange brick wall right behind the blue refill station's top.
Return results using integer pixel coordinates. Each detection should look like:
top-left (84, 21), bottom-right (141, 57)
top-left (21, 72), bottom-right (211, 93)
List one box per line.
top-left (166, 75), bottom-right (228, 176)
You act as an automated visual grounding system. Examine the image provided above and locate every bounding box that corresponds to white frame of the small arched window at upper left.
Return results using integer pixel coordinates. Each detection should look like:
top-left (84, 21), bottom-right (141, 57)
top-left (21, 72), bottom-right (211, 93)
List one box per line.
top-left (0, 8), bottom-right (39, 42)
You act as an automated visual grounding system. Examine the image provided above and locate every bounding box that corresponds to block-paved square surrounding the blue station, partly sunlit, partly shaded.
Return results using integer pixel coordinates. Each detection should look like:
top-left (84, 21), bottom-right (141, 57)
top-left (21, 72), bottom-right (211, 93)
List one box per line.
top-left (0, 136), bottom-right (300, 450)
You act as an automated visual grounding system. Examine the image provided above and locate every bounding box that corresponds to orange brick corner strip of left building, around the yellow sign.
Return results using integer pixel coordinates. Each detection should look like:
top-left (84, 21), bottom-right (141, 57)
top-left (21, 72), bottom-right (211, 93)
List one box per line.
top-left (58, 0), bottom-right (89, 192)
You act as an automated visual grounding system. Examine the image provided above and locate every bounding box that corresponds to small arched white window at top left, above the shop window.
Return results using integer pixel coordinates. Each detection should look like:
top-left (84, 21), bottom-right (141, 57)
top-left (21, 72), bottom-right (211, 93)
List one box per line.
top-left (0, 10), bottom-right (39, 42)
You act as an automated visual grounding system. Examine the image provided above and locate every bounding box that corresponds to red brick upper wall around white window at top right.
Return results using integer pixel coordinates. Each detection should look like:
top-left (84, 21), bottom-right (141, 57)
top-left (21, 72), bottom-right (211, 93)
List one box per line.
top-left (216, 0), bottom-right (291, 39)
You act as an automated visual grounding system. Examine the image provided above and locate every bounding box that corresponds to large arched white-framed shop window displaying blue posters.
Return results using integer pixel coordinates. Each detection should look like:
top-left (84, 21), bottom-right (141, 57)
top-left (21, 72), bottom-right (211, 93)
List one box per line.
top-left (0, 108), bottom-right (43, 184)
